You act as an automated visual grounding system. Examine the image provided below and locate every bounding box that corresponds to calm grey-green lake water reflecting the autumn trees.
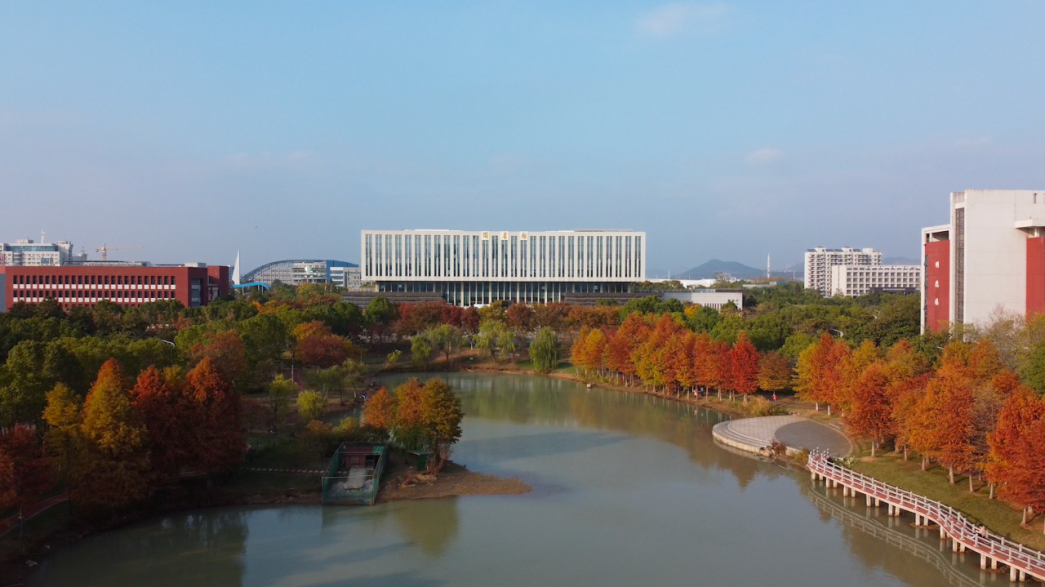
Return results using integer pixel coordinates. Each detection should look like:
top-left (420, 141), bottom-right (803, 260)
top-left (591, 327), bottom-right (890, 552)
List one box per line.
top-left (30, 374), bottom-right (986, 587)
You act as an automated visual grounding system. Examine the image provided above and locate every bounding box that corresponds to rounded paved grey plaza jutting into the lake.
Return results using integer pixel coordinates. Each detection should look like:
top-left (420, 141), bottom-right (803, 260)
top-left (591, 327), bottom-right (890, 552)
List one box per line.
top-left (712, 416), bottom-right (853, 456)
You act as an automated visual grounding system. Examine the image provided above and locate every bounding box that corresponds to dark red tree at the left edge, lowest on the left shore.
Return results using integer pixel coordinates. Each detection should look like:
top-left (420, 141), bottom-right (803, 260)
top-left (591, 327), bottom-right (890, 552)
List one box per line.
top-left (0, 424), bottom-right (54, 511)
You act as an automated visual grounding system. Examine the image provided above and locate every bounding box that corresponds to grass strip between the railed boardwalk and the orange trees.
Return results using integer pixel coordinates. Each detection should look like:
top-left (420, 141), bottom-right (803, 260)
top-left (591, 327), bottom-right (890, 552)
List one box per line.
top-left (853, 454), bottom-right (1045, 550)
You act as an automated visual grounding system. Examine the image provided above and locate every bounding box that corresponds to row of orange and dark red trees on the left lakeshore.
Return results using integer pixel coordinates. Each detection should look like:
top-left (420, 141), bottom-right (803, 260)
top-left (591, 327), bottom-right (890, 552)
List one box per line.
top-left (0, 350), bottom-right (246, 509)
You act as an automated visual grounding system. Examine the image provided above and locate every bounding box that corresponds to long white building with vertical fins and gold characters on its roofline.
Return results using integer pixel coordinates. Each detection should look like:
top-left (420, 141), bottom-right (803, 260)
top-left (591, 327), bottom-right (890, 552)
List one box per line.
top-left (361, 230), bottom-right (646, 306)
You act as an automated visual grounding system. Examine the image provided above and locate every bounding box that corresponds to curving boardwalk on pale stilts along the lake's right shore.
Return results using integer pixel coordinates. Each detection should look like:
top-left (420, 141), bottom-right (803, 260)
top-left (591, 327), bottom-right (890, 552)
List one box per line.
top-left (809, 452), bottom-right (1045, 583)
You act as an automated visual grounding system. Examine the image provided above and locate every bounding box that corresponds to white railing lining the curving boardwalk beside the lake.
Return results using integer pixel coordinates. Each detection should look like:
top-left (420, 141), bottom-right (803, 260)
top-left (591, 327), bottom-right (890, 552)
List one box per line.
top-left (809, 451), bottom-right (1045, 579)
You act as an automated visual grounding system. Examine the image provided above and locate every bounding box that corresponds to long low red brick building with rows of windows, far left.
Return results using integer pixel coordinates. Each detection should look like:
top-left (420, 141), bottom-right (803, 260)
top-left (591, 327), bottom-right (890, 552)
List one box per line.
top-left (0, 264), bottom-right (230, 311)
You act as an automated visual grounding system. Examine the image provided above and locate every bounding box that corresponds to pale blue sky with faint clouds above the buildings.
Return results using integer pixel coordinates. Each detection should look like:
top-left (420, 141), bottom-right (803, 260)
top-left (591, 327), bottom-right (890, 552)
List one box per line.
top-left (0, 0), bottom-right (1045, 271)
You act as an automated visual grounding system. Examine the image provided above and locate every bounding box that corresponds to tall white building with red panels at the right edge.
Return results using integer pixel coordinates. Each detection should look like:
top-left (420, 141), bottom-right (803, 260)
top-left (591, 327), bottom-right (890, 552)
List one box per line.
top-left (921, 190), bottom-right (1045, 332)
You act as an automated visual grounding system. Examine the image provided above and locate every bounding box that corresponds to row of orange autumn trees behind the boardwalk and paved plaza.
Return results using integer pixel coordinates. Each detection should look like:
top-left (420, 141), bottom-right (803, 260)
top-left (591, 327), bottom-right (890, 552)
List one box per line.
top-left (795, 336), bottom-right (1045, 521)
